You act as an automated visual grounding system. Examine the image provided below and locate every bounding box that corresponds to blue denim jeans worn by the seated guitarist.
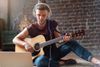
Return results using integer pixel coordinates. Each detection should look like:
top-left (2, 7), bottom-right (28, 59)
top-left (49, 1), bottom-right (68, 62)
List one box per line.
top-left (35, 40), bottom-right (92, 67)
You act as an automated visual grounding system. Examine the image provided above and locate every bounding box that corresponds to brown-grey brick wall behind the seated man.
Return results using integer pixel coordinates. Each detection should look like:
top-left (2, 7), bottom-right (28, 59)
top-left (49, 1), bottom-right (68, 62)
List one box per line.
top-left (18, 0), bottom-right (100, 52)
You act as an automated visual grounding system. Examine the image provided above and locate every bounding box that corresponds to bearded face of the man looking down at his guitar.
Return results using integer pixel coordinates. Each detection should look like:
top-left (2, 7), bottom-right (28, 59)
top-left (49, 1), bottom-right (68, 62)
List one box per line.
top-left (36, 9), bottom-right (49, 25)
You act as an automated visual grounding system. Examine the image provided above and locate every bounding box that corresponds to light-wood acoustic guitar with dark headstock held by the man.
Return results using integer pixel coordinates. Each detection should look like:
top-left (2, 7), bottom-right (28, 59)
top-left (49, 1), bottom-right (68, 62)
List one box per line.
top-left (15, 30), bottom-right (85, 59)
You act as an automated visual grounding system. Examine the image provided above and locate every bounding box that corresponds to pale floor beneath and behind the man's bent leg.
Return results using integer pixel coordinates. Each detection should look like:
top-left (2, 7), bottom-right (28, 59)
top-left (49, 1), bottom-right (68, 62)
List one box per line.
top-left (34, 53), bottom-right (100, 67)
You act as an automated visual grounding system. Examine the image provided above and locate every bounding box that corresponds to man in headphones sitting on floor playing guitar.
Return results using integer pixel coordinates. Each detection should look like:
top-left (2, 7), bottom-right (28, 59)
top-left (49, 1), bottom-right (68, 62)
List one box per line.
top-left (13, 3), bottom-right (100, 67)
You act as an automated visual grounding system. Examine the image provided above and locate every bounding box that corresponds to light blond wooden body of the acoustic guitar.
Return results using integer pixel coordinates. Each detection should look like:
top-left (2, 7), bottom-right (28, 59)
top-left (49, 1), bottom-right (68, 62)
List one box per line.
top-left (15, 35), bottom-right (46, 59)
